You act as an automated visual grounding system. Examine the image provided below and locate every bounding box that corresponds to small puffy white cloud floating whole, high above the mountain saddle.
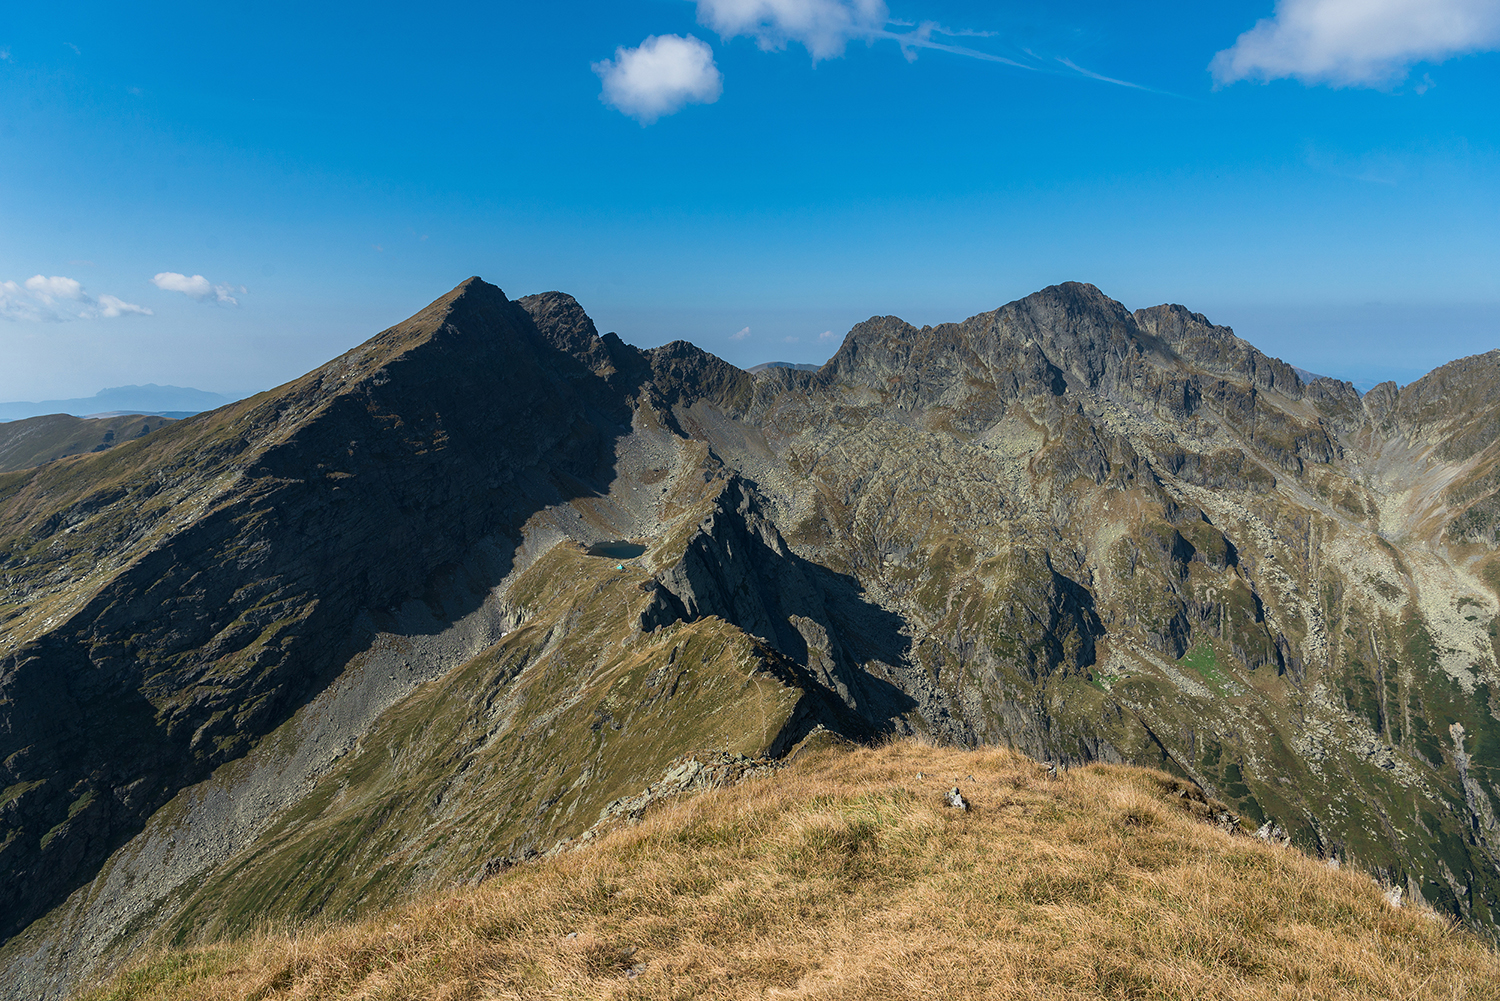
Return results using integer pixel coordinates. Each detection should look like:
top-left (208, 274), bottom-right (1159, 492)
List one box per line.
top-left (593, 35), bottom-right (725, 125)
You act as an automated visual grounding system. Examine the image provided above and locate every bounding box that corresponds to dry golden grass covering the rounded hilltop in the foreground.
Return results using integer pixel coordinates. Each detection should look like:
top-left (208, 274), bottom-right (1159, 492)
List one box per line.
top-left (89, 743), bottom-right (1500, 1001)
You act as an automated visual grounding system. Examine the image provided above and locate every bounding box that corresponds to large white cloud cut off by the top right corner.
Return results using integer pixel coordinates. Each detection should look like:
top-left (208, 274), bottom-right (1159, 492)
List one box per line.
top-left (1211, 0), bottom-right (1500, 87)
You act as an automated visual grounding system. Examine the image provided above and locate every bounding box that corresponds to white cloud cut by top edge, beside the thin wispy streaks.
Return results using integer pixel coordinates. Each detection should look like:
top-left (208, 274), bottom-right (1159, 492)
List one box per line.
top-left (698, 0), bottom-right (890, 60)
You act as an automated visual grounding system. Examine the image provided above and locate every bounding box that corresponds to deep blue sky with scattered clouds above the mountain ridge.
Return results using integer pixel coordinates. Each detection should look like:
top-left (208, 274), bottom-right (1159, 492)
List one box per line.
top-left (0, 0), bottom-right (1500, 399)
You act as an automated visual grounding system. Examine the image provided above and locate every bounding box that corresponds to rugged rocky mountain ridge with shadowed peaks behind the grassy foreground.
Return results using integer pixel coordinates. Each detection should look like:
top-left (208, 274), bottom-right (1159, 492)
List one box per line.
top-left (0, 279), bottom-right (1500, 996)
